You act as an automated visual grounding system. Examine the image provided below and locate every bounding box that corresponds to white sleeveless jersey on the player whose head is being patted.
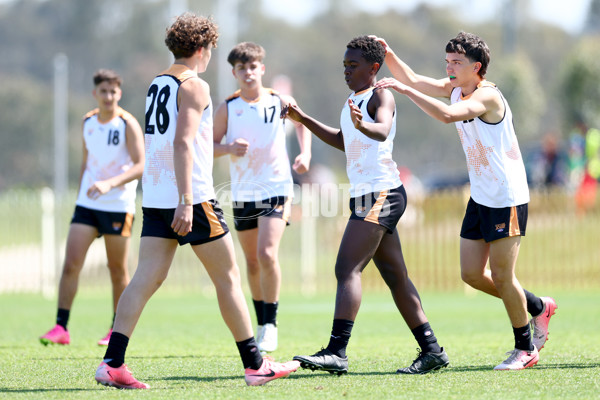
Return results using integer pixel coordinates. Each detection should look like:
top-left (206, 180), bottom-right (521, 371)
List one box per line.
top-left (340, 88), bottom-right (402, 197)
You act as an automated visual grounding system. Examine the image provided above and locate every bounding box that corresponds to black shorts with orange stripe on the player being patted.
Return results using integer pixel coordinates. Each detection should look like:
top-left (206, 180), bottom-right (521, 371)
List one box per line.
top-left (350, 185), bottom-right (406, 233)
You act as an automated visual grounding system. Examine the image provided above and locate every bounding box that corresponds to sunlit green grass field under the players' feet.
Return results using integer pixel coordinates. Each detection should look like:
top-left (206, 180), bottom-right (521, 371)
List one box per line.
top-left (0, 288), bottom-right (600, 400)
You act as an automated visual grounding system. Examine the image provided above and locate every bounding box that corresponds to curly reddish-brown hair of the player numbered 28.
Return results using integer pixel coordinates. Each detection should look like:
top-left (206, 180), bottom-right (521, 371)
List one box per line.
top-left (165, 12), bottom-right (219, 59)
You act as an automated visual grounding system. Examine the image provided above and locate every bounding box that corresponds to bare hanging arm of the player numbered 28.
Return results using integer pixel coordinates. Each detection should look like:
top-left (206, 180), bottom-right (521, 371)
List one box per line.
top-left (171, 78), bottom-right (210, 236)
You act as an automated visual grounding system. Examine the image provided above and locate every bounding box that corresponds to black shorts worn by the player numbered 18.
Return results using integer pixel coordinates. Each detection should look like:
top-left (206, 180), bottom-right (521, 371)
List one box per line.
top-left (71, 205), bottom-right (133, 237)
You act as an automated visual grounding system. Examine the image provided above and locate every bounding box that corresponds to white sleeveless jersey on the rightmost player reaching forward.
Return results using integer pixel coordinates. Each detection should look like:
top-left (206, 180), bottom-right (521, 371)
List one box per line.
top-left (450, 81), bottom-right (529, 208)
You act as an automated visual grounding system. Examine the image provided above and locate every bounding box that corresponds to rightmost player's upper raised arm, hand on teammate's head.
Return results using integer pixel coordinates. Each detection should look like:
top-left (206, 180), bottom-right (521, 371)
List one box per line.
top-left (371, 35), bottom-right (452, 98)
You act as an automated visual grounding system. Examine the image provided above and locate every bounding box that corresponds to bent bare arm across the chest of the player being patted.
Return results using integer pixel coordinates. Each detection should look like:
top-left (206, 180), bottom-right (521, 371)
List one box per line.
top-left (348, 90), bottom-right (396, 142)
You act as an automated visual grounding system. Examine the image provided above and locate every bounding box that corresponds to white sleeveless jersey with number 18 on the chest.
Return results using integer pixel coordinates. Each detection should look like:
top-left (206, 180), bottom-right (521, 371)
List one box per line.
top-left (76, 107), bottom-right (138, 214)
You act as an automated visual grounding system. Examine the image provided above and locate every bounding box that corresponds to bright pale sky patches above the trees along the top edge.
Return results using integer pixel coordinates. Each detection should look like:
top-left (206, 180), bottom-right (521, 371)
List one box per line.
top-left (263, 0), bottom-right (591, 33)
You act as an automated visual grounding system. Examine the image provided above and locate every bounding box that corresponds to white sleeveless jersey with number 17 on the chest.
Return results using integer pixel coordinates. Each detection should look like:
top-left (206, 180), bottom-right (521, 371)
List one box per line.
top-left (226, 89), bottom-right (293, 201)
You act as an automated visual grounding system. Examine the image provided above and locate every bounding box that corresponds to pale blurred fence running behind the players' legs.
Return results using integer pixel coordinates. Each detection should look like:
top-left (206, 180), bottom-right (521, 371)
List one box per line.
top-left (0, 185), bottom-right (600, 296)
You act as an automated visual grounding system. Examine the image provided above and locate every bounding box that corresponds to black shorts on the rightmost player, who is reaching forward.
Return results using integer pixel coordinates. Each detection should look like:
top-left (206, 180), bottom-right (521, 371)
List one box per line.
top-left (460, 198), bottom-right (527, 243)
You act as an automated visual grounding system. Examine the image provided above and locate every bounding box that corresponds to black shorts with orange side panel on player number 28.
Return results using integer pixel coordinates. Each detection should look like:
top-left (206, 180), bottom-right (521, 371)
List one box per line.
top-left (142, 200), bottom-right (229, 246)
